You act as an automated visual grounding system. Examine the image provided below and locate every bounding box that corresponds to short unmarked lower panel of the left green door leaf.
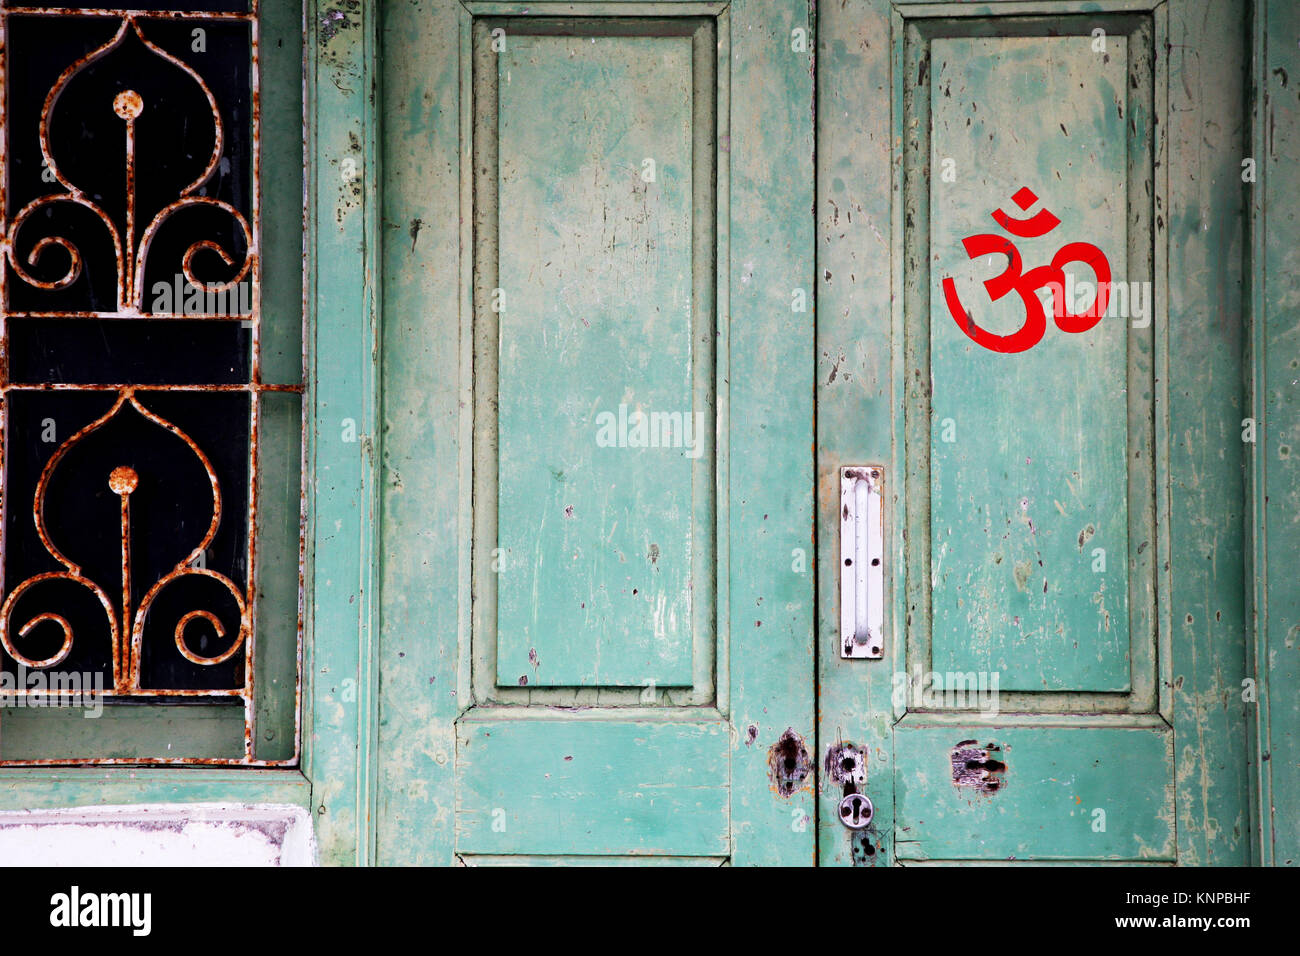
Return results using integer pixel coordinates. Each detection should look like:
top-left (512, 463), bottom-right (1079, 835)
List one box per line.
top-left (456, 715), bottom-right (731, 857)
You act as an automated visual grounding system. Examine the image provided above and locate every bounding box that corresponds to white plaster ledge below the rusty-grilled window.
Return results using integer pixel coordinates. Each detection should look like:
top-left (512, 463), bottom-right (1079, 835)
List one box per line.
top-left (0, 804), bottom-right (316, 866)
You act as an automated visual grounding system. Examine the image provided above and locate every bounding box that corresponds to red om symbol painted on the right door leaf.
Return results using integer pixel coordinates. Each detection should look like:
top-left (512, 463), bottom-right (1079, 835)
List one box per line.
top-left (944, 186), bottom-right (1110, 352)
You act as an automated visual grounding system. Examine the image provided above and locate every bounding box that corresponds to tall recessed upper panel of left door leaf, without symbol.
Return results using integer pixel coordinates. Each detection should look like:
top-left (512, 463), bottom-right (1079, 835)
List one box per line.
top-left (485, 20), bottom-right (715, 687)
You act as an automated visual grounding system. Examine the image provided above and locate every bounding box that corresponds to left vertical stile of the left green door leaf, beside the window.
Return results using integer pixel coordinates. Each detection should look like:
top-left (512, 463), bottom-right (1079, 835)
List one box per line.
top-left (376, 0), bottom-right (462, 866)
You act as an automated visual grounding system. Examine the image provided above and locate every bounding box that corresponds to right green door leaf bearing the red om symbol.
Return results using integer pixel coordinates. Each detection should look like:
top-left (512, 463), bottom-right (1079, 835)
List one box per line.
top-left (818, 0), bottom-right (1251, 864)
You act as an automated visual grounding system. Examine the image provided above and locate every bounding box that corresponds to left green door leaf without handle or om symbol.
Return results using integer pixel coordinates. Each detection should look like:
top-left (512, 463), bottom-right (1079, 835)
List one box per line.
top-left (376, 0), bottom-right (815, 865)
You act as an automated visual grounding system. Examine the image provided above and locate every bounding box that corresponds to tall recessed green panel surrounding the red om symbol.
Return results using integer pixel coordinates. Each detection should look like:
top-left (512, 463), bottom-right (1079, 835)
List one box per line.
top-left (924, 35), bottom-right (1138, 692)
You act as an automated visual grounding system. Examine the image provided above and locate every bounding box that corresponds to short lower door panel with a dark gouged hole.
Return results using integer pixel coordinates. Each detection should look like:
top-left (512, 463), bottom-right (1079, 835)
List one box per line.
top-left (894, 718), bottom-right (1174, 860)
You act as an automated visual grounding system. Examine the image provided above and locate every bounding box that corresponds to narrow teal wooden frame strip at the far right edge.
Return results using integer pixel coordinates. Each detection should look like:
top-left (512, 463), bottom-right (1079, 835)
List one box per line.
top-left (1247, 0), bottom-right (1300, 866)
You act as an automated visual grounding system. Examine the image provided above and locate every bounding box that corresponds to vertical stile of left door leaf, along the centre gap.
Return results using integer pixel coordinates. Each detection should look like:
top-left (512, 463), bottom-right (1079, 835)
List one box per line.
top-left (719, 0), bottom-right (818, 865)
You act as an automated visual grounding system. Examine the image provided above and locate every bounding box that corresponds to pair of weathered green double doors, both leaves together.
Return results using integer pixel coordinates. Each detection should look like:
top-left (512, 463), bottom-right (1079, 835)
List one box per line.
top-left (369, 0), bottom-right (1252, 865)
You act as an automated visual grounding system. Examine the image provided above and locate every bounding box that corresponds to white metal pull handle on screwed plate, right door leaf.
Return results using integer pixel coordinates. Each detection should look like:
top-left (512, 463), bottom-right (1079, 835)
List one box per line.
top-left (840, 464), bottom-right (885, 659)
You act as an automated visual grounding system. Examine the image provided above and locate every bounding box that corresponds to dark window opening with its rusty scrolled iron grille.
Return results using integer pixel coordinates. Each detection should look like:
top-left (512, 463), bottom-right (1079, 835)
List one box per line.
top-left (0, 0), bottom-right (302, 766)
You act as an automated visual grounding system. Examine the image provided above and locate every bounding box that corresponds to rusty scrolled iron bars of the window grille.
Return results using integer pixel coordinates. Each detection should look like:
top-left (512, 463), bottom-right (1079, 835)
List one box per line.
top-left (0, 0), bottom-right (307, 767)
